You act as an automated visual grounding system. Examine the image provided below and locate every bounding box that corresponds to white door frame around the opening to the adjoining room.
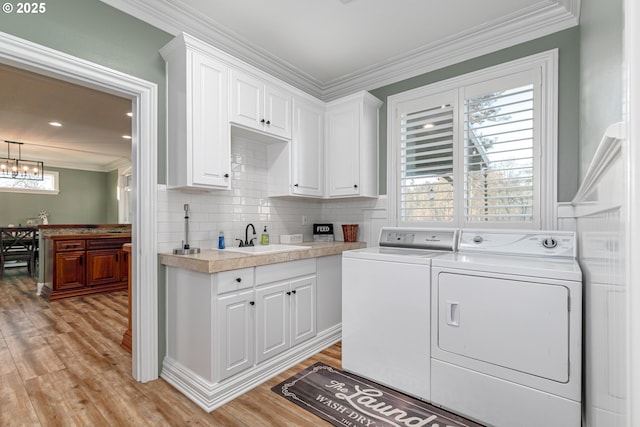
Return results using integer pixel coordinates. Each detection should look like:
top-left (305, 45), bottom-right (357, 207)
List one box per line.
top-left (0, 32), bottom-right (158, 382)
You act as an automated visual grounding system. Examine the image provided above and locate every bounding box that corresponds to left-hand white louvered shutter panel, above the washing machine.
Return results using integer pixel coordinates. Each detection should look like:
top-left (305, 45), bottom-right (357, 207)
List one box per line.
top-left (399, 93), bottom-right (455, 224)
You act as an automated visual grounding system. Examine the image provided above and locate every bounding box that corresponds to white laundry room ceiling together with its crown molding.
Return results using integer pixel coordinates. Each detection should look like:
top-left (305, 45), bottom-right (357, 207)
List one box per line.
top-left (102, 0), bottom-right (580, 100)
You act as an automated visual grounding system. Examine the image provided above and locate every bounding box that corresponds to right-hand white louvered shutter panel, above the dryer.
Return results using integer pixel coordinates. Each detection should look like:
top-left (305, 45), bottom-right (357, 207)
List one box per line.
top-left (462, 72), bottom-right (539, 225)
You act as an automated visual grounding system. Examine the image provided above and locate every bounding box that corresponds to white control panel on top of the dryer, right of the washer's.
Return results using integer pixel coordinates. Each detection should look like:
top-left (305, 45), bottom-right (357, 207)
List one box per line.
top-left (458, 230), bottom-right (576, 258)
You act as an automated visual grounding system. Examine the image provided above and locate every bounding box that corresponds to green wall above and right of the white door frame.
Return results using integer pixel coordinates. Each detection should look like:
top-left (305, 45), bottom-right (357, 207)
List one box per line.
top-left (0, 0), bottom-right (173, 183)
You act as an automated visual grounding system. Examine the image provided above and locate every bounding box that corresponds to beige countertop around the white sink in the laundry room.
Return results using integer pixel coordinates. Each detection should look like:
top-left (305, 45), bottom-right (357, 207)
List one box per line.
top-left (160, 242), bottom-right (367, 274)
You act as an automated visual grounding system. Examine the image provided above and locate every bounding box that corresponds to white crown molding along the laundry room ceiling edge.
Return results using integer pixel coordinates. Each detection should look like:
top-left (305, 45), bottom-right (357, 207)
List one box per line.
top-left (101, 0), bottom-right (580, 101)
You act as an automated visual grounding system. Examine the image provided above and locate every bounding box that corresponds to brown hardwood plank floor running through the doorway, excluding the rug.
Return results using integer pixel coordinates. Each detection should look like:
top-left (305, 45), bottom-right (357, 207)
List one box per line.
top-left (0, 269), bottom-right (341, 427)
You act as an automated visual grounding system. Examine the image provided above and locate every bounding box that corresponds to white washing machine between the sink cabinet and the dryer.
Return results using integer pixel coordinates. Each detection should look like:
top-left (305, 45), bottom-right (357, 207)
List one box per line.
top-left (342, 227), bottom-right (456, 400)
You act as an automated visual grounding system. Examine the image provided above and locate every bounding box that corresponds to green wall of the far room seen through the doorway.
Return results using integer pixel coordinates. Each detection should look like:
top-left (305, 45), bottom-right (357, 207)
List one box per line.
top-left (0, 167), bottom-right (118, 226)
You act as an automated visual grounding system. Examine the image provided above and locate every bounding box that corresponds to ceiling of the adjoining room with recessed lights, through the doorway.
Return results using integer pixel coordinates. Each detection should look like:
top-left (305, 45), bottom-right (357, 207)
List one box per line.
top-left (0, 64), bottom-right (131, 171)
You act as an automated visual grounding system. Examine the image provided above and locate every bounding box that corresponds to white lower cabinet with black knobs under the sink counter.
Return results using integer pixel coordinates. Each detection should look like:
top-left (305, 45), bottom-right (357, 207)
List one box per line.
top-left (161, 258), bottom-right (328, 411)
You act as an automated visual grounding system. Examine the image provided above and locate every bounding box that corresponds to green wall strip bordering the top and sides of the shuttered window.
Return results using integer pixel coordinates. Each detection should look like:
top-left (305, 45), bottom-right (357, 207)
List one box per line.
top-left (370, 27), bottom-right (580, 201)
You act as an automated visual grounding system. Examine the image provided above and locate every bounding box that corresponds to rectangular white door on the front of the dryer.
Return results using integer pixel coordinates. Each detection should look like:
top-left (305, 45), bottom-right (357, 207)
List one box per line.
top-left (435, 272), bottom-right (569, 382)
